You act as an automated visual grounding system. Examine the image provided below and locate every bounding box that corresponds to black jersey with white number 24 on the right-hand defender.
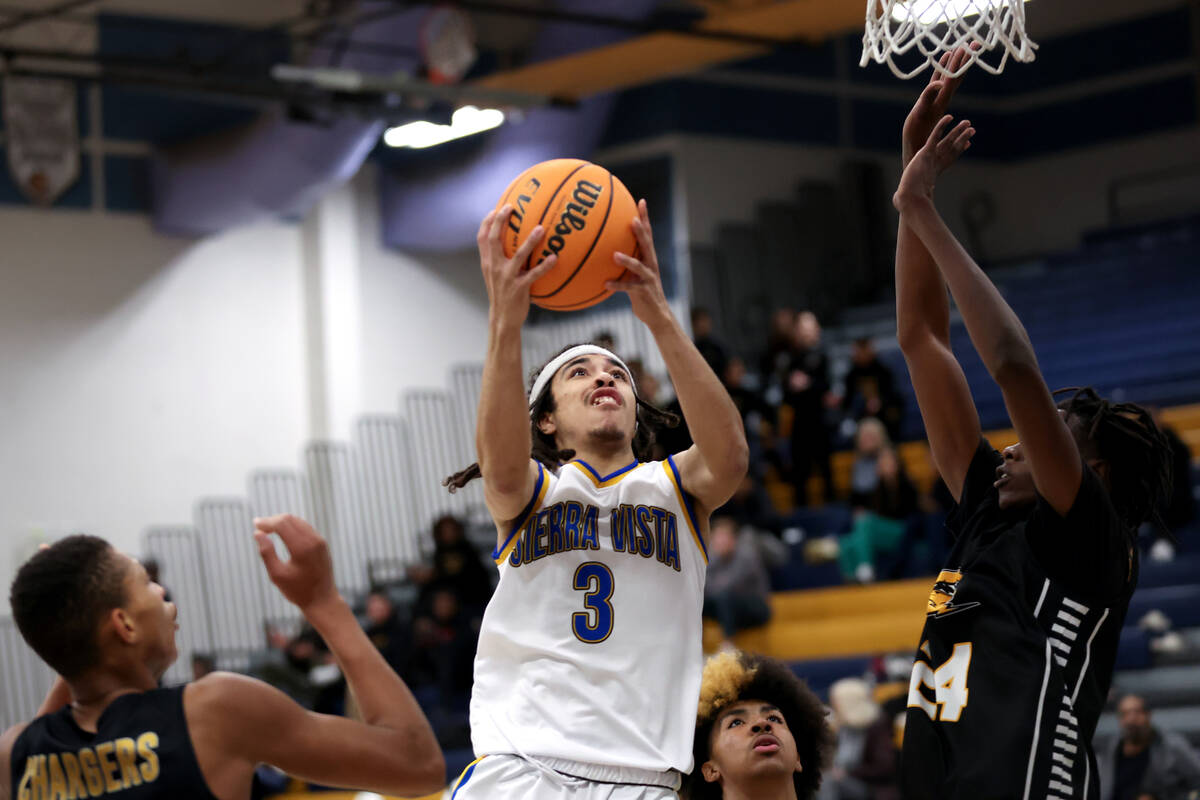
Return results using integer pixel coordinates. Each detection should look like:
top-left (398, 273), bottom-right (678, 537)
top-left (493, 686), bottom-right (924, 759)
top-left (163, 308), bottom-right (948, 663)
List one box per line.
top-left (901, 440), bottom-right (1136, 800)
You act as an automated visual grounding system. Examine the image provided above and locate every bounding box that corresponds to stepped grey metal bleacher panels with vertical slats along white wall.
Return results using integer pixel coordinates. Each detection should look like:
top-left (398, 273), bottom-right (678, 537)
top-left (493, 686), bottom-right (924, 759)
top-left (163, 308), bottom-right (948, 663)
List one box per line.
top-left (0, 301), bottom-right (688, 729)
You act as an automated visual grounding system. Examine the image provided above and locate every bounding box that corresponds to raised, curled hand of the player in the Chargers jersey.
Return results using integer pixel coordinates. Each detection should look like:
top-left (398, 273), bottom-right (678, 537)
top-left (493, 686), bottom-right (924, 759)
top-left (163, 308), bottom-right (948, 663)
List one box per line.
top-left (254, 513), bottom-right (338, 613)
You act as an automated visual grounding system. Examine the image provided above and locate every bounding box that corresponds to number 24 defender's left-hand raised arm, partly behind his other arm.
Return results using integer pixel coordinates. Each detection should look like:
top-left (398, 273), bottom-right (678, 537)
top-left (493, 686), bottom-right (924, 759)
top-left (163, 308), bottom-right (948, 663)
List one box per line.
top-left (896, 50), bottom-right (982, 500)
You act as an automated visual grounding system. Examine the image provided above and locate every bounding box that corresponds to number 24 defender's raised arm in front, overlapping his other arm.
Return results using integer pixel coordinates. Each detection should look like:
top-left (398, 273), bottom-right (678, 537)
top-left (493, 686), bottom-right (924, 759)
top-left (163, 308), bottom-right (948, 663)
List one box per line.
top-left (894, 116), bottom-right (1084, 515)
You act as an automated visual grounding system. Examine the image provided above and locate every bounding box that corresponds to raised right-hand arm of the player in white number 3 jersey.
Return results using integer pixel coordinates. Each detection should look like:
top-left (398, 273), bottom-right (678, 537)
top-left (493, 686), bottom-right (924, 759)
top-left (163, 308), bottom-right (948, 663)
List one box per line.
top-left (608, 200), bottom-right (750, 511)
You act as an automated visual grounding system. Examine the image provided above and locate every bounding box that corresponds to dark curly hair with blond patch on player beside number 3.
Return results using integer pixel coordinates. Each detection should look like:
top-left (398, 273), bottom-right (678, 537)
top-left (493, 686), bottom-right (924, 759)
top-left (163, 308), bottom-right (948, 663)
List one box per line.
top-left (680, 651), bottom-right (834, 800)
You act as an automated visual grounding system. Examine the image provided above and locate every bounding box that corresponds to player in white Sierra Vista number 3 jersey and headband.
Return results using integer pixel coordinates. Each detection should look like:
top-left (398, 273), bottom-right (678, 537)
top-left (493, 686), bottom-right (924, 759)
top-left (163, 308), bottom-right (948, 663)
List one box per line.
top-left (448, 200), bottom-right (748, 800)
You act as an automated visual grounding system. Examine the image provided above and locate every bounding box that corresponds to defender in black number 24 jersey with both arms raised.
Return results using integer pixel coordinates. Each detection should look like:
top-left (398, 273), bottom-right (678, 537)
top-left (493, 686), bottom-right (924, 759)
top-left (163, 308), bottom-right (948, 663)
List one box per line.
top-left (894, 52), bottom-right (1170, 800)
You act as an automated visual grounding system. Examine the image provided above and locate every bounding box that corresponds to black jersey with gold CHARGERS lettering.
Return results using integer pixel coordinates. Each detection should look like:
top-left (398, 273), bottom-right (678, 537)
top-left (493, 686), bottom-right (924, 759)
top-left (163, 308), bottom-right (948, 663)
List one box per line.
top-left (12, 687), bottom-right (215, 800)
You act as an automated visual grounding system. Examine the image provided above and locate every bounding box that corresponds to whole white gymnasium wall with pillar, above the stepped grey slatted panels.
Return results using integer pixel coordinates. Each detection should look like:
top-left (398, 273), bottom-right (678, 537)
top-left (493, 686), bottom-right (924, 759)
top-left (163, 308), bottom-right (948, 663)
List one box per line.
top-left (0, 168), bottom-right (487, 602)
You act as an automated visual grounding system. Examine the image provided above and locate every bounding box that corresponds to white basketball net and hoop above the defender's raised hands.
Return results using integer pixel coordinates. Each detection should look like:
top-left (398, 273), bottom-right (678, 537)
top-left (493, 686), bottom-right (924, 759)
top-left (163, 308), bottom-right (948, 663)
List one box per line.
top-left (858, 0), bottom-right (1038, 78)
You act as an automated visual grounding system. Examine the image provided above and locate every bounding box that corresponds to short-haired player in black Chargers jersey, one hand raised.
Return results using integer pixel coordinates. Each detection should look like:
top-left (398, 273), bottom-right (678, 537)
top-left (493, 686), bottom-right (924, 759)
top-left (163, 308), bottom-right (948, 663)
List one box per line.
top-left (0, 516), bottom-right (445, 800)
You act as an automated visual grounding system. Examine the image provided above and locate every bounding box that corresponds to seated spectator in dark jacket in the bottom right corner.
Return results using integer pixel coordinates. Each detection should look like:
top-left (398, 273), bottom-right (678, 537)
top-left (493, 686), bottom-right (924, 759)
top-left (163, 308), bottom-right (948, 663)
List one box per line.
top-left (1096, 694), bottom-right (1200, 800)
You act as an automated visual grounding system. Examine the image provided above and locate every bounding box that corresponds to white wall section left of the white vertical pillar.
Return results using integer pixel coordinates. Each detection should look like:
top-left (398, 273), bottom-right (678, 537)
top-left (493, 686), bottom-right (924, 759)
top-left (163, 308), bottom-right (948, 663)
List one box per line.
top-left (0, 209), bottom-right (307, 599)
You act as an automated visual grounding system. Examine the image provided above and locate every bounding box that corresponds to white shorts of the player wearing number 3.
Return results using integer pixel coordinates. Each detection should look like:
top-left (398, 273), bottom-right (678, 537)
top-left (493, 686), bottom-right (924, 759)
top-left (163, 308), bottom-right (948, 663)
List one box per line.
top-left (449, 754), bottom-right (679, 800)
